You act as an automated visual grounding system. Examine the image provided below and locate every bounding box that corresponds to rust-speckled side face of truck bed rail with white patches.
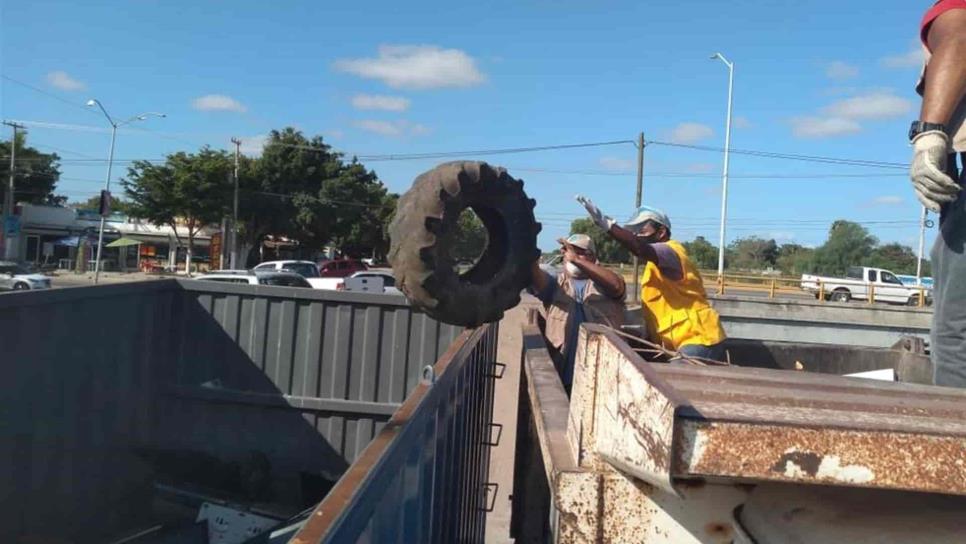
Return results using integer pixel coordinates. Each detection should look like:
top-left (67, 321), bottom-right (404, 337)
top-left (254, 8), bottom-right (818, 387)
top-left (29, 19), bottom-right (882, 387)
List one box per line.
top-left (676, 421), bottom-right (966, 495)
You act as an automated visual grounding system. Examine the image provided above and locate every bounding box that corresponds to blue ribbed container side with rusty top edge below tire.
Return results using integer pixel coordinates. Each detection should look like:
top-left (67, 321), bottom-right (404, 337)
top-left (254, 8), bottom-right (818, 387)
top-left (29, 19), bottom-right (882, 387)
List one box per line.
top-left (294, 324), bottom-right (498, 544)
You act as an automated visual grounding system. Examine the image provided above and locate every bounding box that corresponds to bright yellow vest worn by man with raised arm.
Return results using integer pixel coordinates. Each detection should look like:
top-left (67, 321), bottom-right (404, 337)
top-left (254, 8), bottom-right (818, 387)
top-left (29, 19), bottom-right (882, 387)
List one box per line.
top-left (641, 240), bottom-right (725, 350)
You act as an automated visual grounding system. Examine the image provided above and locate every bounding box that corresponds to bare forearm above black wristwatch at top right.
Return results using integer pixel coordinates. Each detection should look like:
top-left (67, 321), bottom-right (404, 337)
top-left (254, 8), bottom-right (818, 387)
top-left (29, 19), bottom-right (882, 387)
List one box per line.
top-left (919, 9), bottom-right (966, 124)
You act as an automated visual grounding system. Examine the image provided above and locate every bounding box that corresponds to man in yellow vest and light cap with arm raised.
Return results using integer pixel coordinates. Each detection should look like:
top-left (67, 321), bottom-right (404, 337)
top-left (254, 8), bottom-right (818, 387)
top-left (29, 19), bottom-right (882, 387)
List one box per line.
top-left (577, 196), bottom-right (725, 361)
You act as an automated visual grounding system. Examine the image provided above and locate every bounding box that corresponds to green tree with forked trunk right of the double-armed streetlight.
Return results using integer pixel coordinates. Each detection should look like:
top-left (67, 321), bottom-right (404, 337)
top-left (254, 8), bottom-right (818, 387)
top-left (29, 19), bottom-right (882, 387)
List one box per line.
top-left (121, 147), bottom-right (232, 274)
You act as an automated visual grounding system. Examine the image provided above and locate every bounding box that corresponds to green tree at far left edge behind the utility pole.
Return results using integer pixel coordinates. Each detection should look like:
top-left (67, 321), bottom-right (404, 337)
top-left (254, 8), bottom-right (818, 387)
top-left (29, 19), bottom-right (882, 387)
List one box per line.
top-left (0, 133), bottom-right (67, 205)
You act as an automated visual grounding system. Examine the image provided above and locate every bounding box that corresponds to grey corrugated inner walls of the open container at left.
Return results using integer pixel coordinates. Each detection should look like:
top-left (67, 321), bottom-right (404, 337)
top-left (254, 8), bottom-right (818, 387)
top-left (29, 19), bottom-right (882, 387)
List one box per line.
top-left (0, 280), bottom-right (461, 542)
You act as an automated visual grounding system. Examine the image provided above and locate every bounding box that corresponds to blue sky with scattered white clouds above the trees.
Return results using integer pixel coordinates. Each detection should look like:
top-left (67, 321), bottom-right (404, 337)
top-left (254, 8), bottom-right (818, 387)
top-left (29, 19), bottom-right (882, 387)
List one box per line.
top-left (0, 0), bottom-right (931, 249)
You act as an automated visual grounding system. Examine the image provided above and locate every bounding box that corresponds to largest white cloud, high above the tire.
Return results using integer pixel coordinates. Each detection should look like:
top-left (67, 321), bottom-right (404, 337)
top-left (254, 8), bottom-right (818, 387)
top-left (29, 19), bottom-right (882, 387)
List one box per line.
top-left (335, 45), bottom-right (486, 89)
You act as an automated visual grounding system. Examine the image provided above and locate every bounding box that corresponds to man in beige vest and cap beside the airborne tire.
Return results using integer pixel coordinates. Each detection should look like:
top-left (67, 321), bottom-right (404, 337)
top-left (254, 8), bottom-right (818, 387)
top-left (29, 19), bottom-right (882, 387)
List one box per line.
top-left (531, 234), bottom-right (625, 392)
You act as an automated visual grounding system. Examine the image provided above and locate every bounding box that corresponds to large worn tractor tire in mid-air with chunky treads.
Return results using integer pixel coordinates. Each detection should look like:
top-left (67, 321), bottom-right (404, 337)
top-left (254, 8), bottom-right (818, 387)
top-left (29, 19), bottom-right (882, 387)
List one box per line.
top-left (389, 161), bottom-right (541, 327)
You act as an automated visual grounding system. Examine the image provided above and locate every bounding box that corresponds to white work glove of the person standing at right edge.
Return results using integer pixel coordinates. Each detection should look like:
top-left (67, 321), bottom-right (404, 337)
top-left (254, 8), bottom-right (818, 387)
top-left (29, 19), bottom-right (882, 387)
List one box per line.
top-left (909, 130), bottom-right (961, 213)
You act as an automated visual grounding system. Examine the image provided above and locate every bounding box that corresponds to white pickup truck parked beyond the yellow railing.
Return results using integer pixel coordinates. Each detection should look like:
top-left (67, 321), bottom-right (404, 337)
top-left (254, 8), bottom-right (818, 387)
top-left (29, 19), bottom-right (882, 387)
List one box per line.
top-left (802, 266), bottom-right (932, 306)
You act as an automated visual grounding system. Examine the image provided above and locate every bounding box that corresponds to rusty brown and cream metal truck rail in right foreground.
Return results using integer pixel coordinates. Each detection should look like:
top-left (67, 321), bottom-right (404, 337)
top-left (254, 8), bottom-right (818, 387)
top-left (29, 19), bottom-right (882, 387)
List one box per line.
top-left (572, 326), bottom-right (966, 495)
